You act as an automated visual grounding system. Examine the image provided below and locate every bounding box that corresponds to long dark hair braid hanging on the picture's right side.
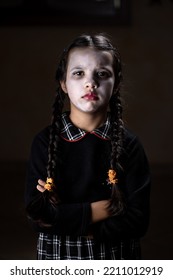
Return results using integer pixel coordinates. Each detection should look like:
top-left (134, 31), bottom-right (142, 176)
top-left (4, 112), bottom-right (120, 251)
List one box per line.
top-left (106, 46), bottom-right (125, 215)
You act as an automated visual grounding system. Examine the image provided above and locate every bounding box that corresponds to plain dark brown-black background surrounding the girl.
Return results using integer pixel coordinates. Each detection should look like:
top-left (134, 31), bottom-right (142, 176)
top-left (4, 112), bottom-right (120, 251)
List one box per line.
top-left (0, 0), bottom-right (173, 259)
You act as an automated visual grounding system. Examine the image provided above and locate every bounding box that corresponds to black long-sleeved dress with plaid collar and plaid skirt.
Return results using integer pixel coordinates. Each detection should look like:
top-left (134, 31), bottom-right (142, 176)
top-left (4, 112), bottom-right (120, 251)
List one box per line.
top-left (25, 113), bottom-right (150, 259)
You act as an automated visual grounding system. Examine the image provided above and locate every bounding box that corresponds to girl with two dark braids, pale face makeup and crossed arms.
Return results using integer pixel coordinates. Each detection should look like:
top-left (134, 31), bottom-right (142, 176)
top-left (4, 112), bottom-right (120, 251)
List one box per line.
top-left (26, 34), bottom-right (150, 260)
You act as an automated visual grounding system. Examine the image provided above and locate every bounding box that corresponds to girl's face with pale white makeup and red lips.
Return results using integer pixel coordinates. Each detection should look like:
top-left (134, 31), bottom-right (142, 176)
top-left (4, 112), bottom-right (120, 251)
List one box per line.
top-left (61, 47), bottom-right (115, 113)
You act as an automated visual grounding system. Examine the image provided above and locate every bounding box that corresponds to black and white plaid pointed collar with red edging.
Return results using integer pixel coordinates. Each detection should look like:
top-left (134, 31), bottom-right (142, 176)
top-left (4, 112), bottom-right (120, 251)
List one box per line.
top-left (61, 112), bottom-right (110, 142)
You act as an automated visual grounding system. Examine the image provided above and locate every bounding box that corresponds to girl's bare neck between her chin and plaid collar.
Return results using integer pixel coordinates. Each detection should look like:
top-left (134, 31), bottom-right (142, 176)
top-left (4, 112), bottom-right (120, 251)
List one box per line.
top-left (70, 111), bottom-right (107, 132)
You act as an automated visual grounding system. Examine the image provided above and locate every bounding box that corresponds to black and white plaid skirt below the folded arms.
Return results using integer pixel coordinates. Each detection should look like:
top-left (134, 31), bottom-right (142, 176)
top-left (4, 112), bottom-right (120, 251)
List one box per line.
top-left (37, 233), bottom-right (141, 260)
